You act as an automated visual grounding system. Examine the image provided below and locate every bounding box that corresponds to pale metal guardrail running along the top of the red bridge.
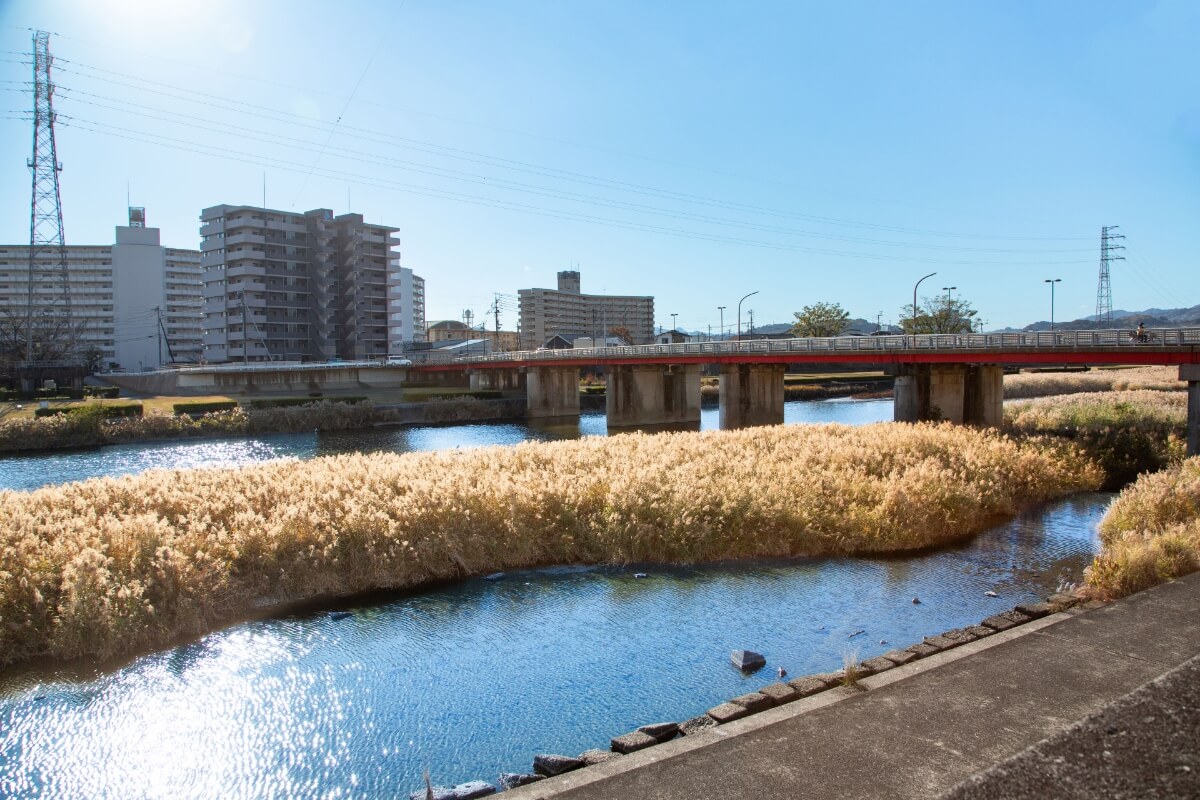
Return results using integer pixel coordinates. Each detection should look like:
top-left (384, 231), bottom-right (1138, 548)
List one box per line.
top-left (418, 327), bottom-right (1200, 365)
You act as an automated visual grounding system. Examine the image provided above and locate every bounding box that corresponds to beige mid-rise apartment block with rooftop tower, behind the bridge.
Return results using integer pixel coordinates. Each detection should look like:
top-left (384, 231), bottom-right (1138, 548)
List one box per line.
top-left (517, 270), bottom-right (654, 350)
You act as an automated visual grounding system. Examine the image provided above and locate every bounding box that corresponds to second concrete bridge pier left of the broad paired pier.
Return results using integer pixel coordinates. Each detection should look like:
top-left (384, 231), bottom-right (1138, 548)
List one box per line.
top-left (605, 365), bottom-right (700, 429)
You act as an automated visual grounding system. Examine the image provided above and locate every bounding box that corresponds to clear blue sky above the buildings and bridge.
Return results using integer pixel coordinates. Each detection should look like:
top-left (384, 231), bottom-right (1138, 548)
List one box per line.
top-left (0, 0), bottom-right (1200, 330)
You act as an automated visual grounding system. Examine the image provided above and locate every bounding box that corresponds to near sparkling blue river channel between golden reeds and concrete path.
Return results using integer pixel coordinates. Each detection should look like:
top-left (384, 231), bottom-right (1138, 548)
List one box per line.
top-left (0, 402), bottom-right (1111, 798)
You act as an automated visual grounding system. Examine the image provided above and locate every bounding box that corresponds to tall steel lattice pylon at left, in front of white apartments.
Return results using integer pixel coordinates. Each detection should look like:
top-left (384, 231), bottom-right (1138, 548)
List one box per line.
top-left (25, 31), bottom-right (77, 367)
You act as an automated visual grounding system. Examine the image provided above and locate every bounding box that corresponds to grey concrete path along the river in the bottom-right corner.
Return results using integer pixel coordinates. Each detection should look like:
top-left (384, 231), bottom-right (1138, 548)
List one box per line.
top-left (503, 573), bottom-right (1200, 800)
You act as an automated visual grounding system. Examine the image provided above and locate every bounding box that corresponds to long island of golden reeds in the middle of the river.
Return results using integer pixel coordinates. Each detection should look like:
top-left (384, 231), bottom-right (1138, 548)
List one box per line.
top-left (0, 425), bottom-right (1102, 662)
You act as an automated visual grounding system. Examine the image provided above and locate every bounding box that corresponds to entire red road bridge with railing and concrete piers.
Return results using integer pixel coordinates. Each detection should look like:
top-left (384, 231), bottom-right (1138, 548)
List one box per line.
top-left (409, 327), bottom-right (1200, 453)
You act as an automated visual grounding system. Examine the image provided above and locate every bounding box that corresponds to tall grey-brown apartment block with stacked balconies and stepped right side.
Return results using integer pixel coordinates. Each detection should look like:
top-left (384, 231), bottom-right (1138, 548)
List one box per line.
top-left (200, 205), bottom-right (400, 361)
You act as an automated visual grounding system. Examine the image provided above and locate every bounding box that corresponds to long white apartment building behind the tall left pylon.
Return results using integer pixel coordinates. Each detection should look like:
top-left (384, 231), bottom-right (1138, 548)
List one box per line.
top-left (0, 209), bottom-right (203, 372)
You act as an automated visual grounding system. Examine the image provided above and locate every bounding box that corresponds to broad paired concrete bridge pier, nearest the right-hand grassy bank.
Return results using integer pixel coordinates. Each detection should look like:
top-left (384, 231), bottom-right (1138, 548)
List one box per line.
top-left (893, 363), bottom-right (1004, 428)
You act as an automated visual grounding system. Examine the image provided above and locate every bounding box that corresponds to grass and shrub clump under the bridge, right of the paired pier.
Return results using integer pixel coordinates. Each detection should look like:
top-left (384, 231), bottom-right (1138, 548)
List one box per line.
top-left (1004, 391), bottom-right (1188, 489)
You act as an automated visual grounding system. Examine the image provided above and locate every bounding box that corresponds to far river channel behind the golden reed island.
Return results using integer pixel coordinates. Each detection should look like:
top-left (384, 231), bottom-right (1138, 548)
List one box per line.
top-left (0, 399), bottom-right (892, 489)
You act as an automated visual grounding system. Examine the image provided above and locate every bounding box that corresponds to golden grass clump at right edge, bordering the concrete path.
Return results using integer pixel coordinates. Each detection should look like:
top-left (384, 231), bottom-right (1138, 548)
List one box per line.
top-left (1087, 457), bottom-right (1200, 599)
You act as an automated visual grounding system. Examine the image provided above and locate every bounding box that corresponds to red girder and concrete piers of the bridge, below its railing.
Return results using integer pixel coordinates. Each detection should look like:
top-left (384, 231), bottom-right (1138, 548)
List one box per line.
top-left (412, 338), bottom-right (1200, 455)
